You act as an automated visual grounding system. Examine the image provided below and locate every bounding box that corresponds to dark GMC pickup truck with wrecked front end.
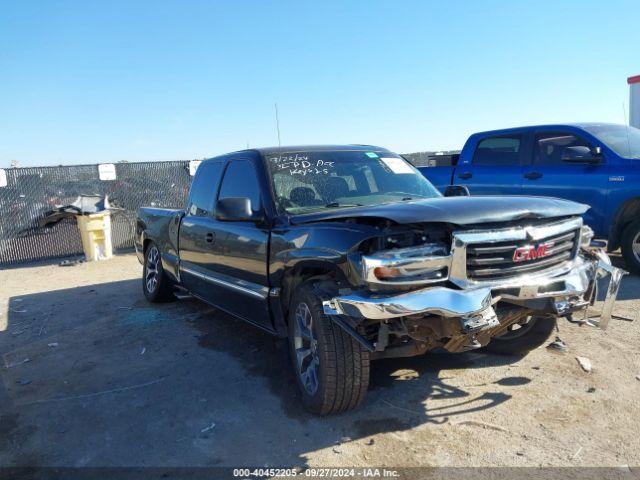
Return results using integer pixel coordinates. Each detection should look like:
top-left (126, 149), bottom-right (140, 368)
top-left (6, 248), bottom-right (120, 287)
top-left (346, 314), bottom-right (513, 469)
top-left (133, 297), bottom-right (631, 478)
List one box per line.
top-left (135, 145), bottom-right (623, 415)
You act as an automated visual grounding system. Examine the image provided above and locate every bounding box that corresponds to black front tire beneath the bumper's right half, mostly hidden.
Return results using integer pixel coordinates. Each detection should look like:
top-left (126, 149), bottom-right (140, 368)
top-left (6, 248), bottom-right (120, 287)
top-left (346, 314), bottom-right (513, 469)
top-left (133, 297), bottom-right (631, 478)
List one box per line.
top-left (484, 317), bottom-right (556, 355)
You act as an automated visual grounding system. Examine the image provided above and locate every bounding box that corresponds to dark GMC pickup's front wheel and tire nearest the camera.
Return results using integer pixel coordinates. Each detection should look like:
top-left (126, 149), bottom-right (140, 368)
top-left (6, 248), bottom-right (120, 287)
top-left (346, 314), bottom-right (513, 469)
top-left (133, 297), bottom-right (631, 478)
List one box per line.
top-left (288, 282), bottom-right (369, 415)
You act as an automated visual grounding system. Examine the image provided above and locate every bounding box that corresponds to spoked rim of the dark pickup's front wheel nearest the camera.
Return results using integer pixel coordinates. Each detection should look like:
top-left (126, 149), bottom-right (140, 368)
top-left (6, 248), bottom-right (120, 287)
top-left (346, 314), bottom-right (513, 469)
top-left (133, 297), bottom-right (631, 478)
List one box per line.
top-left (293, 303), bottom-right (320, 395)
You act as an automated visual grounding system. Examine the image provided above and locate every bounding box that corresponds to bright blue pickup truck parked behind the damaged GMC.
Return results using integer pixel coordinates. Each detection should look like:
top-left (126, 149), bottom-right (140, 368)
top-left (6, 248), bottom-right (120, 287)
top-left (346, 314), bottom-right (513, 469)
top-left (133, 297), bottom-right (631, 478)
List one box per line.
top-left (420, 123), bottom-right (640, 274)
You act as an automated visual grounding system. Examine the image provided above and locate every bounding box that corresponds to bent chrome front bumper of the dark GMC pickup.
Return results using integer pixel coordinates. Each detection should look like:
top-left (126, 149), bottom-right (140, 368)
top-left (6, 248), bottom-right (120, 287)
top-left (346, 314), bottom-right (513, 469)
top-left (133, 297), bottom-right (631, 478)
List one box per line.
top-left (323, 250), bottom-right (626, 329)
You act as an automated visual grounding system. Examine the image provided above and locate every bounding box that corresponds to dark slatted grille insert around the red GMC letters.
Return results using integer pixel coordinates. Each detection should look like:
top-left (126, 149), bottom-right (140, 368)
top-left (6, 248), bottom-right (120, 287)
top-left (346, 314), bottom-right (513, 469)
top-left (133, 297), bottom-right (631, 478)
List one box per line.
top-left (467, 230), bottom-right (579, 280)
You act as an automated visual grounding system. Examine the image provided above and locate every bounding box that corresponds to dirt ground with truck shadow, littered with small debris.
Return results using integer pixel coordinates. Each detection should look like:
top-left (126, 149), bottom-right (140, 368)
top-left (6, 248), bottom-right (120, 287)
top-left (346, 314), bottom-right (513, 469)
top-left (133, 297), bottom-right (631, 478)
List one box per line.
top-left (0, 255), bottom-right (640, 467)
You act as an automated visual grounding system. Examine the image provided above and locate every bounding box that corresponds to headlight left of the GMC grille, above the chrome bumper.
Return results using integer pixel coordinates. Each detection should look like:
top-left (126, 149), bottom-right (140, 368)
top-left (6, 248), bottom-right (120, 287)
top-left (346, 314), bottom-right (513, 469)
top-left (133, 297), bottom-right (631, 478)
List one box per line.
top-left (362, 243), bottom-right (451, 286)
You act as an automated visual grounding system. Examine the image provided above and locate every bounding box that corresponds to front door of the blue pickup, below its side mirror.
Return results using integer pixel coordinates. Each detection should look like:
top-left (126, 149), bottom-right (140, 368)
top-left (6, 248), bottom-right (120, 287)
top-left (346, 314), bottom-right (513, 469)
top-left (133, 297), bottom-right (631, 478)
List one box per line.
top-left (522, 129), bottom-right (609, 234)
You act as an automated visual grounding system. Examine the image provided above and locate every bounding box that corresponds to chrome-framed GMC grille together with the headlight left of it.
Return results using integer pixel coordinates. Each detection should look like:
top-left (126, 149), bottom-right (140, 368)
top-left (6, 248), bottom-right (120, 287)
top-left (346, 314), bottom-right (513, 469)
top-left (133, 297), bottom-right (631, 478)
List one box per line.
top-left (362, 218), bottom-right (590, 288)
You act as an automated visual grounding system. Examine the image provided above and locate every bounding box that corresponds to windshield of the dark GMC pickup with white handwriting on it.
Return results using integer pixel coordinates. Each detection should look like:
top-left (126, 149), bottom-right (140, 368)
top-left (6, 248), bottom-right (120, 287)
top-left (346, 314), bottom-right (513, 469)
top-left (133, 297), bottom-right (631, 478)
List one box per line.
top-left (266, 150), bottom-right (440, 214)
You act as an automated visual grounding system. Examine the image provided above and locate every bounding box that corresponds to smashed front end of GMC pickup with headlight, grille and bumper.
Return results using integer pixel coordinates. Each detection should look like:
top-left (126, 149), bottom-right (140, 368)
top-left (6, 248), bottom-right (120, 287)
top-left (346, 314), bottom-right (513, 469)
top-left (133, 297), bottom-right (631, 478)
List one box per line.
top-left (323, 217), bottom-right (626, 357)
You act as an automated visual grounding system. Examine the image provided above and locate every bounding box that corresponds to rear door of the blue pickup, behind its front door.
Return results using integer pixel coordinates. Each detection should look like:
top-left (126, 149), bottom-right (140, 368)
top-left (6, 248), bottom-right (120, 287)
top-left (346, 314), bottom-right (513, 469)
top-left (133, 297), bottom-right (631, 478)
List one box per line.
top-left (452, 134), bottom-right (527, 195)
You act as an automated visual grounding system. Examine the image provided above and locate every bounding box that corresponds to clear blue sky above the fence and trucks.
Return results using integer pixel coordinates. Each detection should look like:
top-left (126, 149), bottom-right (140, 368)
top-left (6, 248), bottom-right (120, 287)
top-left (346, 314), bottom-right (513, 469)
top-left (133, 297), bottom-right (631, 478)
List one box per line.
top-left (0, 0), bottom-right (640, 167)
